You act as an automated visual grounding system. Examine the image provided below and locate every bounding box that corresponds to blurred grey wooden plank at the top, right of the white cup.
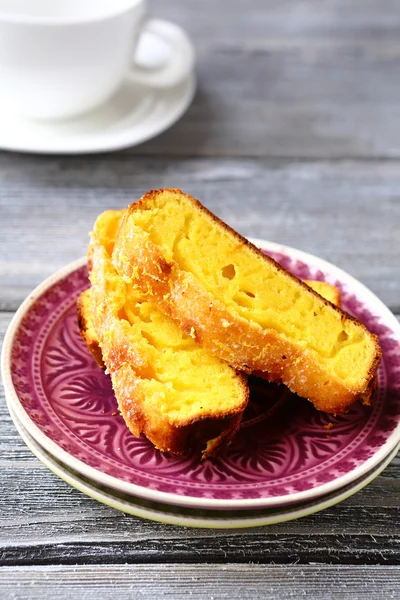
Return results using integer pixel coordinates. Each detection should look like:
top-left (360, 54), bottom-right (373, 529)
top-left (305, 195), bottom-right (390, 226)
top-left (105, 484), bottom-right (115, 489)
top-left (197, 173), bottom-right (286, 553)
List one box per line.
top-left (131, 0), bottom-right (400, 158)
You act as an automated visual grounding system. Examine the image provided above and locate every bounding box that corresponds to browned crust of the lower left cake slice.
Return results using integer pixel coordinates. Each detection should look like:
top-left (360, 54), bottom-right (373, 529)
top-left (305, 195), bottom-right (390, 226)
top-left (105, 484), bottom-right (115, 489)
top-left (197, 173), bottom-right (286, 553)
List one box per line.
top-left (78, 211), bottom-right (249, 458)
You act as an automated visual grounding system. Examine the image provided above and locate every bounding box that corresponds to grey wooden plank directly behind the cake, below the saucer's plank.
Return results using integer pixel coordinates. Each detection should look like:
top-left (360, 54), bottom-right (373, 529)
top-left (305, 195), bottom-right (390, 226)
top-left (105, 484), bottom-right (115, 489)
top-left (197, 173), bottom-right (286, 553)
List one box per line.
top-left (0, 157), bottom-right (400, 310)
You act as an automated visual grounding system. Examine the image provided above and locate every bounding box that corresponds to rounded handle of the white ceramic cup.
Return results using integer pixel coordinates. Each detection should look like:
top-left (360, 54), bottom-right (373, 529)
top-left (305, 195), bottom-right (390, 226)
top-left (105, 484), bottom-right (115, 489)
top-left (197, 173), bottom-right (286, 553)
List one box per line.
top-left (129, 19), bottom-right (194, 88)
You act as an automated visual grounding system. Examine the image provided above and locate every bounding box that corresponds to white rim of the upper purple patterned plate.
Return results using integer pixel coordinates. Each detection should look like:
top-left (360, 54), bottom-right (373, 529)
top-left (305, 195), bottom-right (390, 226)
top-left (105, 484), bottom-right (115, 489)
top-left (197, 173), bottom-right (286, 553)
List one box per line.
top-left (1, 238), bottom-right (400, 510)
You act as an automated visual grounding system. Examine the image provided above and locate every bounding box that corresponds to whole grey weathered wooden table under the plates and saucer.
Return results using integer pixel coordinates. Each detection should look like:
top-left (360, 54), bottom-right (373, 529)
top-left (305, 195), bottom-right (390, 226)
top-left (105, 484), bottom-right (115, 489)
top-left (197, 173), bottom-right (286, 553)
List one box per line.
top-left (0, 0), bottom-right (400, 600)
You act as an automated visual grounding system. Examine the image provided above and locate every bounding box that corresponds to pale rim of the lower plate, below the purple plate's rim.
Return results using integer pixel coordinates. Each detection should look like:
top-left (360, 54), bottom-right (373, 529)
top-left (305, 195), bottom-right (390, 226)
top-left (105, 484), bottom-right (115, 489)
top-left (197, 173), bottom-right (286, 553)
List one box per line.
top-left (7, 404), bottom-right (400, 529)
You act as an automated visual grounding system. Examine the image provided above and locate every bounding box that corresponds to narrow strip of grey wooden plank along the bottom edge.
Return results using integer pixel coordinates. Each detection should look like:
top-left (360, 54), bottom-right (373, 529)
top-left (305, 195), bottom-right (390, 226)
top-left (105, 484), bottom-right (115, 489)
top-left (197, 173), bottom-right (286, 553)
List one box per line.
top-left (0, 564), bottom-right (400, 600)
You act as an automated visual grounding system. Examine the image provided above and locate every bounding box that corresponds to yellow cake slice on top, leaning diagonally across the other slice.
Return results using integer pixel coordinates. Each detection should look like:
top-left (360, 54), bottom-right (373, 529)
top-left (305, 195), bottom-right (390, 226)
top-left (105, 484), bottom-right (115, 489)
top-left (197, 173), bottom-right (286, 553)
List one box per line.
top-left (113, 189), bottom-right (380, 413)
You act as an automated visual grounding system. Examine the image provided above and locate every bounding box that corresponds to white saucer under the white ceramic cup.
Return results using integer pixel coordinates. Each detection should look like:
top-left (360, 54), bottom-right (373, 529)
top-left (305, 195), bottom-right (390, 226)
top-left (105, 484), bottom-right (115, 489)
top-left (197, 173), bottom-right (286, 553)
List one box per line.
top-left (0, 74), bottom-right (196, 154)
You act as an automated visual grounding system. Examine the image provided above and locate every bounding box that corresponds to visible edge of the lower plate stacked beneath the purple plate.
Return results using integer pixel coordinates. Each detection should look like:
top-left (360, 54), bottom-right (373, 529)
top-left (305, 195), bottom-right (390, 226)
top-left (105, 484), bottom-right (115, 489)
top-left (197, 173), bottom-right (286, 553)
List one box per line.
top-left (8, 405), bottom-right (399, 529)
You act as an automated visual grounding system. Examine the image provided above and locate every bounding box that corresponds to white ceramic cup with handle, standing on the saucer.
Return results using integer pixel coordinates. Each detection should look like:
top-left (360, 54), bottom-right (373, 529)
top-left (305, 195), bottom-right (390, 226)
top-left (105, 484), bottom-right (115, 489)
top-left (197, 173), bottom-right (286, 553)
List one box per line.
top-left (0, 0), bottom-right (194, 119)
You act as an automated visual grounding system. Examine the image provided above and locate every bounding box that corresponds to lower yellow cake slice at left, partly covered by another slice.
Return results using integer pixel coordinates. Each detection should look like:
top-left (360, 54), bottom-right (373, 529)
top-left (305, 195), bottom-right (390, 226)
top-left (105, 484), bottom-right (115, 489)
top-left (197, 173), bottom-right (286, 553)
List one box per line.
top-left (78, 211), bottom-right (249, 458)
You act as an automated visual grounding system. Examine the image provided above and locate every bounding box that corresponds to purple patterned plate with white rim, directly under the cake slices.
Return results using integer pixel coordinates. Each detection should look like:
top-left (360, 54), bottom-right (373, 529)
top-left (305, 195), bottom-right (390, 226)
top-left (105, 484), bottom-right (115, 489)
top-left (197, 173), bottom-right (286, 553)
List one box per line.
top-left (2, 240), bottom-right (400, 509)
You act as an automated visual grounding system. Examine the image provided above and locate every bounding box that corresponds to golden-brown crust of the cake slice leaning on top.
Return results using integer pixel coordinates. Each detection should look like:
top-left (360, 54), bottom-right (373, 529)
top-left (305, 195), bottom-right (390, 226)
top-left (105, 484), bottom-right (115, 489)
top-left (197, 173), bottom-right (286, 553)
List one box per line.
top-left (113, 189), bottom-right (380, 413)
